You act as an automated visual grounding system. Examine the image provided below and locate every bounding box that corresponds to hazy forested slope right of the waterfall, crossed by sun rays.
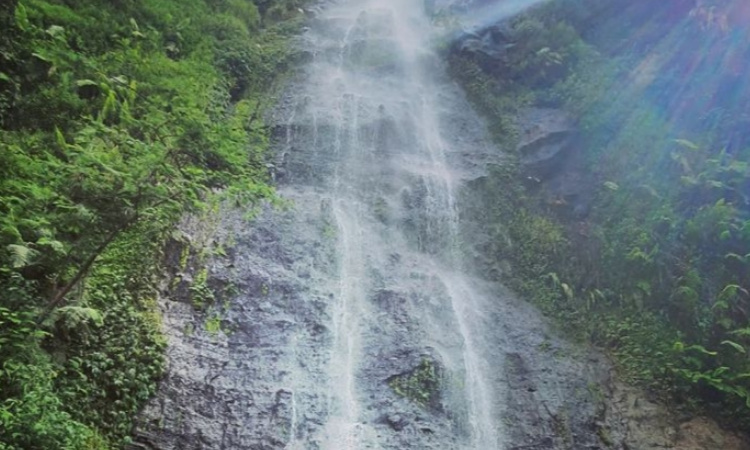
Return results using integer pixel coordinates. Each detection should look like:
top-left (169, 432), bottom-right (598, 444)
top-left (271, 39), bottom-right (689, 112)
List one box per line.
top-left (448, 0), bottom-right (750, 428)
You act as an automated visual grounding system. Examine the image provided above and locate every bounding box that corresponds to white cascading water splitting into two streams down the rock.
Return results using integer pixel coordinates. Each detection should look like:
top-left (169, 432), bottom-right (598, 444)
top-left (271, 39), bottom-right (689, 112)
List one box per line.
top-left (285, 0), bottom-right (500, 450)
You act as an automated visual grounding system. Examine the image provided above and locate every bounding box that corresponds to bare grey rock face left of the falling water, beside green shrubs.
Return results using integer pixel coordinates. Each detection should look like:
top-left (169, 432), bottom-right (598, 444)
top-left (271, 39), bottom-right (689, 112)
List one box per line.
top-left (136, 202), bottom-right (338, 449)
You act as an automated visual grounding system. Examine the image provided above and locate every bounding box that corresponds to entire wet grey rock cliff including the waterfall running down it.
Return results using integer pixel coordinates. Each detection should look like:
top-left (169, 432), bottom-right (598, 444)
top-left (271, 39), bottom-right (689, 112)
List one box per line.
top-left (130, 0), bottom-right (742, 450)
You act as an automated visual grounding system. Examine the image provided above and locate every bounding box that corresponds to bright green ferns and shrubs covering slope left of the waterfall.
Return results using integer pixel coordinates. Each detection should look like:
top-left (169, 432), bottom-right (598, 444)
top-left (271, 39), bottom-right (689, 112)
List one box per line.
top-left (0, 0), bottom-right (301, 444)
